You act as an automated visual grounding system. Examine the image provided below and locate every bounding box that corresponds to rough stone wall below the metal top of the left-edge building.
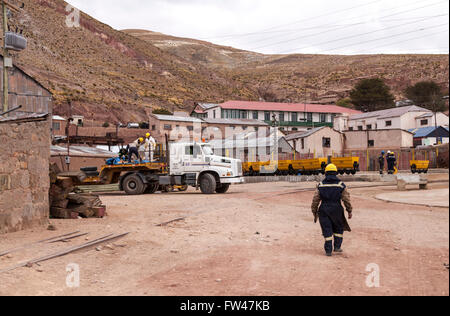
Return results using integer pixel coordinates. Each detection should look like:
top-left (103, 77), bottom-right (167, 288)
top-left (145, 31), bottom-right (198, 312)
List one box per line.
top-left (0, 120), bottom-right (50, 234)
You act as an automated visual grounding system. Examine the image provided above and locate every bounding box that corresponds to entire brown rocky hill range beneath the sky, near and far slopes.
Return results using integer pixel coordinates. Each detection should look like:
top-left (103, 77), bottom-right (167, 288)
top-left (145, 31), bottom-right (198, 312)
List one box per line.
top-left (5, 0), bottom-right (449, 123)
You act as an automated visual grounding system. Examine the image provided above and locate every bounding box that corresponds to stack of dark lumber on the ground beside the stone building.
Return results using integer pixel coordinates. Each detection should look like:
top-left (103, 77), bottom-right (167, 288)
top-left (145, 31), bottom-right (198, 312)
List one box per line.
top-left (49, 166), bottom-right (106, 219)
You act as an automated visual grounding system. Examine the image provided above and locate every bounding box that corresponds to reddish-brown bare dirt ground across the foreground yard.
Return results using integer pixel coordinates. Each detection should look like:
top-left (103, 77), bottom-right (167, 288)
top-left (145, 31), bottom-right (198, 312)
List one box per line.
top-left (0, 175), bottom-right (449, 296)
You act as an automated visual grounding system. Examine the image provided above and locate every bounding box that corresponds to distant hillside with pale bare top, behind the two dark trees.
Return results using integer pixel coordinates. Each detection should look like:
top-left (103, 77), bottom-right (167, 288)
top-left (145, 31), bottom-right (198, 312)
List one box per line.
top-left (124, 30), bottom-right (449, 103)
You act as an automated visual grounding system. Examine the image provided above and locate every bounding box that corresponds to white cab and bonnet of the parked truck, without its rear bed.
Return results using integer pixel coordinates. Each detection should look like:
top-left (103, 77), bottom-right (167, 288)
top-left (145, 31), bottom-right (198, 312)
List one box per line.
top-left (167, 142), bottom-right (244, 194)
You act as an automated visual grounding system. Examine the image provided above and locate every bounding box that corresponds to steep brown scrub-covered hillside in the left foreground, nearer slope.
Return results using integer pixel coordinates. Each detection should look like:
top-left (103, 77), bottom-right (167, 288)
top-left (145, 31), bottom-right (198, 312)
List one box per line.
top-left (10, 0), bottom-right (254, 122)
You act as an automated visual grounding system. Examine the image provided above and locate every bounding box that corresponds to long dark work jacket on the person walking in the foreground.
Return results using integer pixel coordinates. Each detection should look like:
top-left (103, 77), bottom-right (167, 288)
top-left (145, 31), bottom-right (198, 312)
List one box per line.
top-left (318, 175), bottom-right (352, 232)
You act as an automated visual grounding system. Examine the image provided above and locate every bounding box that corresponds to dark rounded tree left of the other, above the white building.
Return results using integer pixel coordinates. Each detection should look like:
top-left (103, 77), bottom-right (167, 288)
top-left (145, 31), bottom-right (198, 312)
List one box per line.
top-left (350, 78), bottom-right (395, 112)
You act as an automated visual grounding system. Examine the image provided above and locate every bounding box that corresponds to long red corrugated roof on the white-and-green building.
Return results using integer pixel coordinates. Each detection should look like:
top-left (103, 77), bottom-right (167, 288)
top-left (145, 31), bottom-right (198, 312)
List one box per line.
top-left (219, 101), bottom-right (361, 114)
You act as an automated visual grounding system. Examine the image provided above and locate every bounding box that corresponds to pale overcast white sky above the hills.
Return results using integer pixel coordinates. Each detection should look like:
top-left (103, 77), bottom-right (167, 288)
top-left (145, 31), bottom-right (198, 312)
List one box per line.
top-left (69, 0), bottom-right (449, 54)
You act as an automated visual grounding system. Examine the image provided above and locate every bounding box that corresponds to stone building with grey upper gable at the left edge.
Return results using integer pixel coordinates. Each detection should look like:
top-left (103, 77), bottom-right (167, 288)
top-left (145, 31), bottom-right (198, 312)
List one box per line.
top-left (0, 58), bottom-right (52, 233)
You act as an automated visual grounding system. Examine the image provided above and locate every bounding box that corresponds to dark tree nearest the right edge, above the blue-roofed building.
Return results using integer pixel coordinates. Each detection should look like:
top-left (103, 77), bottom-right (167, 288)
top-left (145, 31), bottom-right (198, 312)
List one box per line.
top-left (405, 81), bottom-right (447, 144)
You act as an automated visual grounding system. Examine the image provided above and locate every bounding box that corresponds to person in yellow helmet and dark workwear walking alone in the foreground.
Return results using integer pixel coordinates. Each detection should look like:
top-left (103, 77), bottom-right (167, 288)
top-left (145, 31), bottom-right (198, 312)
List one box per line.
top-left (311, 164), bottom-right (353, 257)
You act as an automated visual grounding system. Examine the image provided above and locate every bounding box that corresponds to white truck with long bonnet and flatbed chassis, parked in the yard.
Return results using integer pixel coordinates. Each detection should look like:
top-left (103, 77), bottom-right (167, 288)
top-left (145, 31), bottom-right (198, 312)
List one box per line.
top-left (119, 142), bottom-right (244, 195)
